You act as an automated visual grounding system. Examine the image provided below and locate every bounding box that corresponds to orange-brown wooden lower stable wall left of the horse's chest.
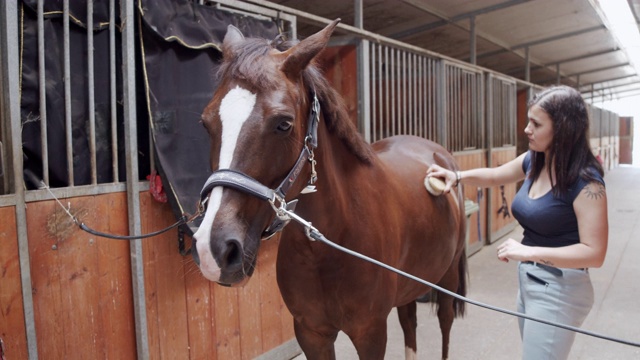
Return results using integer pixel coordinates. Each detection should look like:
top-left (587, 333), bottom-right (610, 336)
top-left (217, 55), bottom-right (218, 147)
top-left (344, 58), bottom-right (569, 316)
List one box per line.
top-left (0, 193), bottom-right (294, 359)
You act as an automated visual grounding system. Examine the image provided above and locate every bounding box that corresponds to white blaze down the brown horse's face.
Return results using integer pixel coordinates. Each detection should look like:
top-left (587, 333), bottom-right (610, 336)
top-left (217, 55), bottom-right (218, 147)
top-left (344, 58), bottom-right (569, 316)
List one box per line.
top-left (193, 86), bottom-right (256, 281)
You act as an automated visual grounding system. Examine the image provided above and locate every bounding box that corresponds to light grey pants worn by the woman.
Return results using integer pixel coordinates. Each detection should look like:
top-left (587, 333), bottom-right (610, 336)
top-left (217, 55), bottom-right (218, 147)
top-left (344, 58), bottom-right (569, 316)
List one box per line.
top-left (517, 263), bottom-right (593, 360)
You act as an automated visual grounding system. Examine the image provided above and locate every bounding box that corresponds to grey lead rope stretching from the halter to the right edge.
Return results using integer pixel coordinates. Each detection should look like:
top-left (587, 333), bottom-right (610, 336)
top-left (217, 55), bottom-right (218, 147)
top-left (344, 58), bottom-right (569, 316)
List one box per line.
top-left (280, 204), bottom-right (640, 347)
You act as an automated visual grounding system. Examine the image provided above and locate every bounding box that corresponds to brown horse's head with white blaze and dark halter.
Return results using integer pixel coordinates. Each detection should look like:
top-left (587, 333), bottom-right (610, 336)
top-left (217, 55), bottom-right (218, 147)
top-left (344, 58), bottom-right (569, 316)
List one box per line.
top-left (194, 20), bottom-right (338, 285)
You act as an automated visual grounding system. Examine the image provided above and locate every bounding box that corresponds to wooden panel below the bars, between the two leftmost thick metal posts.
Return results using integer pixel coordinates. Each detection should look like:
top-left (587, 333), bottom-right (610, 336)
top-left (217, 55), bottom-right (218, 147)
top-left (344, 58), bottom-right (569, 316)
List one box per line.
top-left (27, 194), bottom-right (136, 359)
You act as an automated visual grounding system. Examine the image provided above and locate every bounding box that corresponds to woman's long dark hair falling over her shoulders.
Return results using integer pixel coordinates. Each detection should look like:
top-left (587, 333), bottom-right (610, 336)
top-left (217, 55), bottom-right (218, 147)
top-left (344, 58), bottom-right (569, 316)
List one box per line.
top-left (529, 86), bottom-right (604, 196)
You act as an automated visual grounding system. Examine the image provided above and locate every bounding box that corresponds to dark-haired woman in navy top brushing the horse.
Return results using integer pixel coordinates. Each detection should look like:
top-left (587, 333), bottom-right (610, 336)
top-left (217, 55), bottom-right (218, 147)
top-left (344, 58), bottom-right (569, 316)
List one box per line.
top-left (427, 86), bottom-right (609, 360)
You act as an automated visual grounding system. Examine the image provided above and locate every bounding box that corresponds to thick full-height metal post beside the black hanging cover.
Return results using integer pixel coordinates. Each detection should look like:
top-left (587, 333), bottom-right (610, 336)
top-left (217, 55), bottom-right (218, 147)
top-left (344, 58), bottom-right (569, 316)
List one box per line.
top-left (120, 1), bottom-right (149, 360)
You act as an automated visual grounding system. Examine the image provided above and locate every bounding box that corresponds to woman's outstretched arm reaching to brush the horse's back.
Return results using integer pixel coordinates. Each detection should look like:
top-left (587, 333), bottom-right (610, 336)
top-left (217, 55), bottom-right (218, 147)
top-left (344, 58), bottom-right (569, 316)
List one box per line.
top-left (427, 152), bottom-right (527, 193)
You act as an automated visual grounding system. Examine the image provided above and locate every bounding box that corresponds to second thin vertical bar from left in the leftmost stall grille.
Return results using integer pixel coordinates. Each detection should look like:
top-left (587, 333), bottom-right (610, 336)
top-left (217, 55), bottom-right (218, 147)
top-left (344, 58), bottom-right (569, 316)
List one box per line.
top-left (62, 0), bottom-right (74, 186)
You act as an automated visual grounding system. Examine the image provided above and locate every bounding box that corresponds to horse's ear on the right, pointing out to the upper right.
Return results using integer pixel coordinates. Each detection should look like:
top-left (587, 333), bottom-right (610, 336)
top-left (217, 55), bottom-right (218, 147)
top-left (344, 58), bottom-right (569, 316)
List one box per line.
top-left (281, 19), bottom-right (340, 77)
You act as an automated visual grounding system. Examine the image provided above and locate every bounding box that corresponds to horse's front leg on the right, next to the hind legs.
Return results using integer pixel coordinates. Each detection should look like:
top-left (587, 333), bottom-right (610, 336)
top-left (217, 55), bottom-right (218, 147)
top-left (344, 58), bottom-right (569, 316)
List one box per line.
top-left (345, 317), bottom-right (387, 360)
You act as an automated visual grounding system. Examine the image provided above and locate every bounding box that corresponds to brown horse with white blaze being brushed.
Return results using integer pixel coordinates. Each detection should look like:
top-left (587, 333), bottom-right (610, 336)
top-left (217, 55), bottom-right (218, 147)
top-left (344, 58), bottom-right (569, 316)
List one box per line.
top-left (194, 20), bottom-right (466, 359)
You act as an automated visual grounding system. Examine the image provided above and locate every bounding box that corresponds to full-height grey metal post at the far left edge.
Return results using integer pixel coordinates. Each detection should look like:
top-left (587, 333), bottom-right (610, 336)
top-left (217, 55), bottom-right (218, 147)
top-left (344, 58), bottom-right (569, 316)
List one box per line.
top-left (0, 0), bottom-right (38, 360)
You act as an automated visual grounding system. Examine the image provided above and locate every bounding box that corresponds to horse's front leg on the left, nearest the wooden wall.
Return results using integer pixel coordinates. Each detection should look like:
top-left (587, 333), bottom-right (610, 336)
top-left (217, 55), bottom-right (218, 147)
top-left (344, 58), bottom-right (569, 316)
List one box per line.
top-left (293, 321), bottom-right (338, 360)
